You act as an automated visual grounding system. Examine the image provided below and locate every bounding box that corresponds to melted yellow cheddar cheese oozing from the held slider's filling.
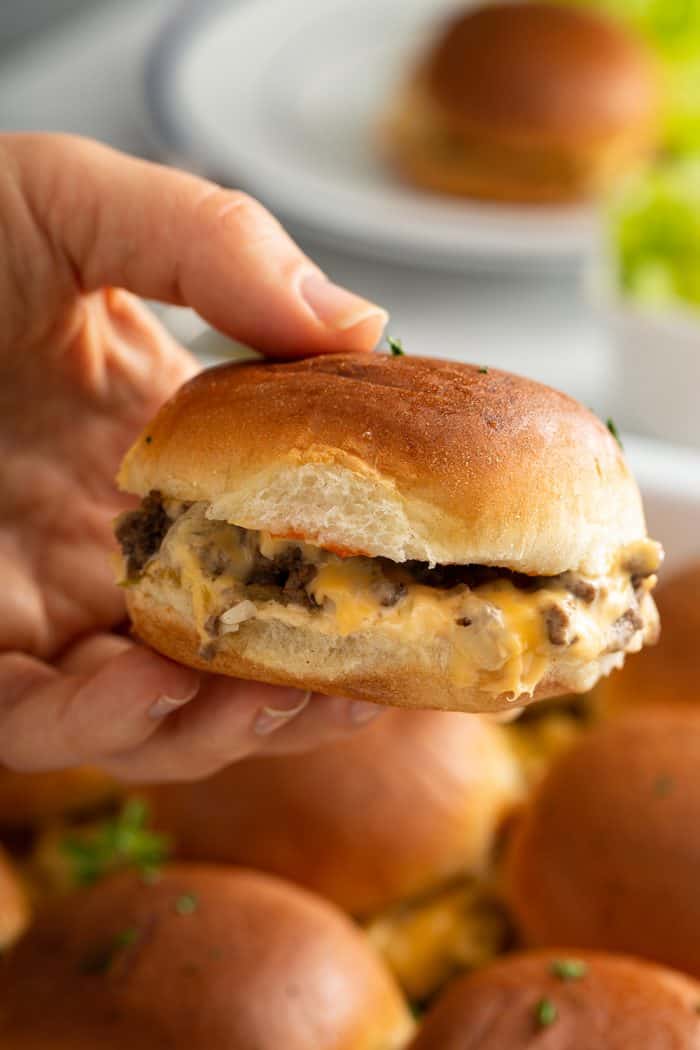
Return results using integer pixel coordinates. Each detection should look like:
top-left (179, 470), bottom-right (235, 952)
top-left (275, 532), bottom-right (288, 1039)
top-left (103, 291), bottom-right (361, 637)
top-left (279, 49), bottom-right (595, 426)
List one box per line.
top-left (138, 504), bottom-right (658, 698)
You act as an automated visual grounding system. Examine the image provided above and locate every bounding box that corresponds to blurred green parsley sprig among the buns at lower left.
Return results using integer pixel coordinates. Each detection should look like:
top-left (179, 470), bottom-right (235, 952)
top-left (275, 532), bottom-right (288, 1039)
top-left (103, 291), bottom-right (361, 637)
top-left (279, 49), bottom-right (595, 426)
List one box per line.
top-left (61, 799), bottom-right (170, 886)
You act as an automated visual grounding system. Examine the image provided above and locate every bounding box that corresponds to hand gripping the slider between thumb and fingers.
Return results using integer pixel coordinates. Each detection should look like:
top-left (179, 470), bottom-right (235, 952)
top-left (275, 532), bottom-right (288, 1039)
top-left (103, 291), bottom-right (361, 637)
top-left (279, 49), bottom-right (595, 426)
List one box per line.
top-left (0, 135), bottom-right (386, 781)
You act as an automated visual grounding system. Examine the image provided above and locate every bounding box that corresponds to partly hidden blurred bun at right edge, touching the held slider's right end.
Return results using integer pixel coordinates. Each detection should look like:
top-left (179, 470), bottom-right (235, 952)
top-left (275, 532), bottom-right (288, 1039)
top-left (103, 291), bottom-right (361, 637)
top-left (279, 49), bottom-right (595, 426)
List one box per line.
top-left (596, 563), bottom-right (700, 714)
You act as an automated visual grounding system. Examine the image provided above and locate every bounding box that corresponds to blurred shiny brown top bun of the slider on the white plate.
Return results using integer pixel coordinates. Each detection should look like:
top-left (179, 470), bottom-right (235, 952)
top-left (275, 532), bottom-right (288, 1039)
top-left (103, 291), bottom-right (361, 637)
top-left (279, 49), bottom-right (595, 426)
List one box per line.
top-left (425, 3), bottom-right (656, 142)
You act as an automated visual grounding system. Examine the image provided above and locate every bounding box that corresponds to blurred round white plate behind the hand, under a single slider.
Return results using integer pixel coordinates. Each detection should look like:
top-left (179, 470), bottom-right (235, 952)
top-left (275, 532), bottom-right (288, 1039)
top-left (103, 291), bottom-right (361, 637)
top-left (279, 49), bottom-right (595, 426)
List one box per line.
top-left (146, 0), bottom-right (595, 270)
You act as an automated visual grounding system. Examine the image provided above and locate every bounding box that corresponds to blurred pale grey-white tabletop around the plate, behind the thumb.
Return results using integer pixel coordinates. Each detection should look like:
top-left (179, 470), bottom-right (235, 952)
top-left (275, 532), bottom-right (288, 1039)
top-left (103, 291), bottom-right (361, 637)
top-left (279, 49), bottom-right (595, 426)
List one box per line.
top-left (0, 0), bottom-right (610, 414)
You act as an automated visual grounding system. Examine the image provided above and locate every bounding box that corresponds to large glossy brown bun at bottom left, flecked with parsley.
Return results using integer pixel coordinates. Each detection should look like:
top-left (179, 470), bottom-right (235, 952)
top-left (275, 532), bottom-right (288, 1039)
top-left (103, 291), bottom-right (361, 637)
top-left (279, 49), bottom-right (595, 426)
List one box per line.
top-left (0, 866), bottom-right (411, 1050)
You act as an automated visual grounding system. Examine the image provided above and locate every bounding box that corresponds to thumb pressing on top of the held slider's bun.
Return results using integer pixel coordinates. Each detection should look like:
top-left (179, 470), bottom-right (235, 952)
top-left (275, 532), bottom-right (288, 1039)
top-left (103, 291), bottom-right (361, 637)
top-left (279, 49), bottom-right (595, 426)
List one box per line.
top-left (3, 134), bottom-right (387, 356)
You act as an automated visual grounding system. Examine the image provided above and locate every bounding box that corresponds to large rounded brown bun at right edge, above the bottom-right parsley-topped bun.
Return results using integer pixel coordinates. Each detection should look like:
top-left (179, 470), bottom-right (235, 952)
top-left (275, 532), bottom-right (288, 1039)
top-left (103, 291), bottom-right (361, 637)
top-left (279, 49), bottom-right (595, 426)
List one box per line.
top-left (507, 708), bottom-right (700, 975)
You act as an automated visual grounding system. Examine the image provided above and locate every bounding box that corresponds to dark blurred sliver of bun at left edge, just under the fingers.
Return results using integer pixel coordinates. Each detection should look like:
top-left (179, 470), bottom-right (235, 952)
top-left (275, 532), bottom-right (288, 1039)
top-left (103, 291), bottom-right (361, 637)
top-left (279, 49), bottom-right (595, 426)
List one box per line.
top-left (0, 768), bottom-right (121, 827)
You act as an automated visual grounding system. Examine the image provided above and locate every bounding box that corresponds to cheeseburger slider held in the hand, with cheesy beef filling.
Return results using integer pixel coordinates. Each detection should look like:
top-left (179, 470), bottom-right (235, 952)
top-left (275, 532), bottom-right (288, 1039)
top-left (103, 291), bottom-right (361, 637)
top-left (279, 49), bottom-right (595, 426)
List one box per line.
top-left (116, 354), bottom-right (660, 712)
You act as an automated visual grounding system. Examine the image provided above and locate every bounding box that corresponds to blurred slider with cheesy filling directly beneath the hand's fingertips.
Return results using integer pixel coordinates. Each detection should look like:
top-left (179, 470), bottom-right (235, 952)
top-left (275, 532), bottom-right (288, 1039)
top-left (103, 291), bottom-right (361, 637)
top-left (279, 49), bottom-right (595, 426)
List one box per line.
top-left (145, 711), bottom-right (523, 1001)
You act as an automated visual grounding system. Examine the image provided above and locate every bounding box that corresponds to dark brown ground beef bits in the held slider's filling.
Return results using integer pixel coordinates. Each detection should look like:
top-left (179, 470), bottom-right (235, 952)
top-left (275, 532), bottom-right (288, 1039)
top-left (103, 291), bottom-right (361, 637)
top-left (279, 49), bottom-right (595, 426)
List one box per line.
top-left (115, 491), bottom-right (653, 652)
